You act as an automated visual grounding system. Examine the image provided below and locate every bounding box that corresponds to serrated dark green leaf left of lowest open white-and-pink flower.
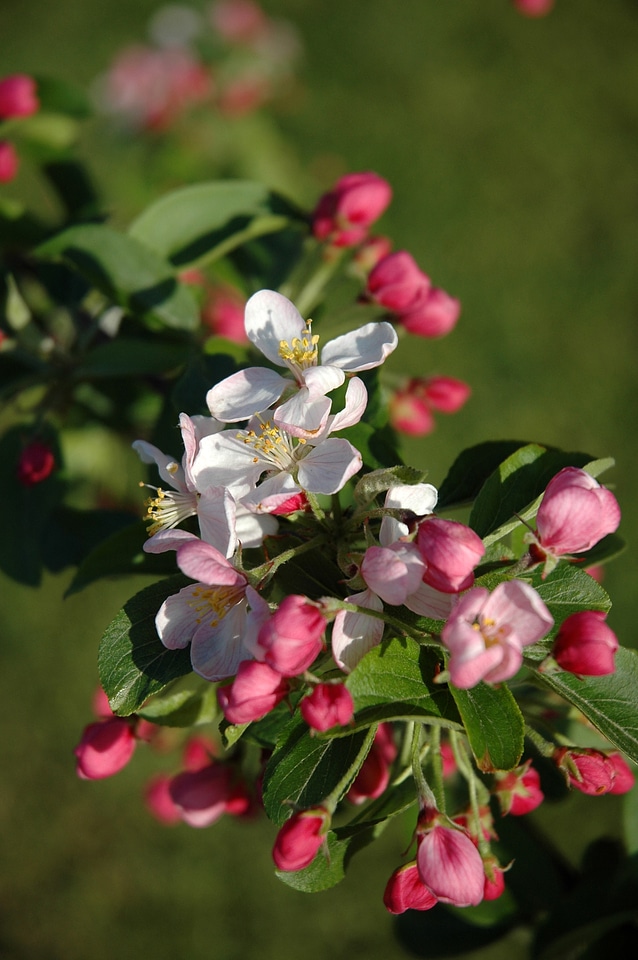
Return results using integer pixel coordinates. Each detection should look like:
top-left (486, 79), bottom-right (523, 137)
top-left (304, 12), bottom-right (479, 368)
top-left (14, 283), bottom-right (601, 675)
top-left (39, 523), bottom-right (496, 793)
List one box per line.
top-left (98, 576), bottom-right (192, 717)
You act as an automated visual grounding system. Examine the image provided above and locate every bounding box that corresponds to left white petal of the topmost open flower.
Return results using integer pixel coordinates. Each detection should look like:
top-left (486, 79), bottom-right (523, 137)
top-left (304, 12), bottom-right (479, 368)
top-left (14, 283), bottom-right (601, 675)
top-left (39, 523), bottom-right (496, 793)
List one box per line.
top-left (206, 367), bottom-right (290, 423)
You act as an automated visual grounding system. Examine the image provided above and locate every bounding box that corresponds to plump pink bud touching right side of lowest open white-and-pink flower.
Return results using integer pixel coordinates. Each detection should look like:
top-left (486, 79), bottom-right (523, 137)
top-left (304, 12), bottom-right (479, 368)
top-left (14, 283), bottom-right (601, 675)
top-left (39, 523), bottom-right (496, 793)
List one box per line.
top-left (257, 594), bottom-right (326, 677)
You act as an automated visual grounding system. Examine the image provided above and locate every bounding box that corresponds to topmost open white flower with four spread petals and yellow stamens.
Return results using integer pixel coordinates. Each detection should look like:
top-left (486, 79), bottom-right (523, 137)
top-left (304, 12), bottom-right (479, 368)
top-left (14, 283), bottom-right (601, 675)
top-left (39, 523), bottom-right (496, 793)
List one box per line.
top-left (206, 290), bottom-right (398, 439)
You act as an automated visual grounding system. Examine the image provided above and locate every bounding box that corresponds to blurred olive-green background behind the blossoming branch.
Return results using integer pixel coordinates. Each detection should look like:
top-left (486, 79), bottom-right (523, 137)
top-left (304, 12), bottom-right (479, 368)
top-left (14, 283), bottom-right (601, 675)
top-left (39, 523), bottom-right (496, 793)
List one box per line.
top-left (0, 0), bottom-right (638, 960)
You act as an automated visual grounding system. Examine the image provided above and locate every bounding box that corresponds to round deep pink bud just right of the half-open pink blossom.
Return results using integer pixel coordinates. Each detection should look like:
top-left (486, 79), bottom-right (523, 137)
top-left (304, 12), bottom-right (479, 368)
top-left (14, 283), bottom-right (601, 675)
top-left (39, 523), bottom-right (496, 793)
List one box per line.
top-left (552, 610), bottom-right (618, 677)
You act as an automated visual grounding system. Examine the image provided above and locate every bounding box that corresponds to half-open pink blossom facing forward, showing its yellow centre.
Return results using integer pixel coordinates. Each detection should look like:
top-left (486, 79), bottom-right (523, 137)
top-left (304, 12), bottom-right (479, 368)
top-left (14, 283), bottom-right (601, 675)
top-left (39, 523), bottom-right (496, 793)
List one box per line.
top-left (441, 580), bottom-right (554, 690)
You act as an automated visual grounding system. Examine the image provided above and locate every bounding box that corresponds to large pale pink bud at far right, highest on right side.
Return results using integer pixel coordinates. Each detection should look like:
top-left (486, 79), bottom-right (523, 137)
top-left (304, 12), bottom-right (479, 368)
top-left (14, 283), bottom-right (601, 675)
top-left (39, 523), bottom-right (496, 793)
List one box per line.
top-left (530, 467), bottom-right (620, 570)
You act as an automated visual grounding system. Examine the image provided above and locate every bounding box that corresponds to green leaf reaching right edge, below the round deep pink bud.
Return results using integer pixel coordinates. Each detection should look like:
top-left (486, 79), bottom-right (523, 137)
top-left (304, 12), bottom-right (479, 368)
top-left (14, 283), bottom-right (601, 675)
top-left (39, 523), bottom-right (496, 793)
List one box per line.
top-left (534, 647), bottom-right (638, 763)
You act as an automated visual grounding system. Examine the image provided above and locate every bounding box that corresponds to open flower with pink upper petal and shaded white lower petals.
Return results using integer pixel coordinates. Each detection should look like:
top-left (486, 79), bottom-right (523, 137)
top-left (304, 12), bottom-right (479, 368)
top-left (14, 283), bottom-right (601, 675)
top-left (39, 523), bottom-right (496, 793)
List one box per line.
top-left (155, 535), bottom-right (269, 680)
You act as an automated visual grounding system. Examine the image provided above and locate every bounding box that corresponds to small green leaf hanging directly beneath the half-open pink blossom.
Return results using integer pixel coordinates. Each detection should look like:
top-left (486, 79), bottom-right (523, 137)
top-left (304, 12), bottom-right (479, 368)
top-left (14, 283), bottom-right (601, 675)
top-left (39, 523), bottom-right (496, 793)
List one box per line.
top-left (450, 682), bottom-right (525, 773)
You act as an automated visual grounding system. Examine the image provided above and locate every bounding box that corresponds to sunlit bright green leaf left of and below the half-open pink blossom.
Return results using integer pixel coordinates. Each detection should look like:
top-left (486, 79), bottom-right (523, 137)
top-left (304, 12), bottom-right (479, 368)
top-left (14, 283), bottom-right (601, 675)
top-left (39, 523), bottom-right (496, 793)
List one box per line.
top-left (346, 637), bottom-right (460, 729)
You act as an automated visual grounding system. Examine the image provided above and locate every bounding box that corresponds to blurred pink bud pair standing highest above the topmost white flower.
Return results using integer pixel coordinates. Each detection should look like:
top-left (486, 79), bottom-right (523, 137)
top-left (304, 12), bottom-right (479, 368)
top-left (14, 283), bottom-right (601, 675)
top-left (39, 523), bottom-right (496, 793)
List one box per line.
top-left (312, 172), bottom-right (392, 247)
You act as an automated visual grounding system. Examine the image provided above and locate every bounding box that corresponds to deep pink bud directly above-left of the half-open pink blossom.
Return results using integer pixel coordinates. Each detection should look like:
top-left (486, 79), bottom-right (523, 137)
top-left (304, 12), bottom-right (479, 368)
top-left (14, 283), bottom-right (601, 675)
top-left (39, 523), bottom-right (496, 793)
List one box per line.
top-left (417, 517), bottom-right (485, 593)
